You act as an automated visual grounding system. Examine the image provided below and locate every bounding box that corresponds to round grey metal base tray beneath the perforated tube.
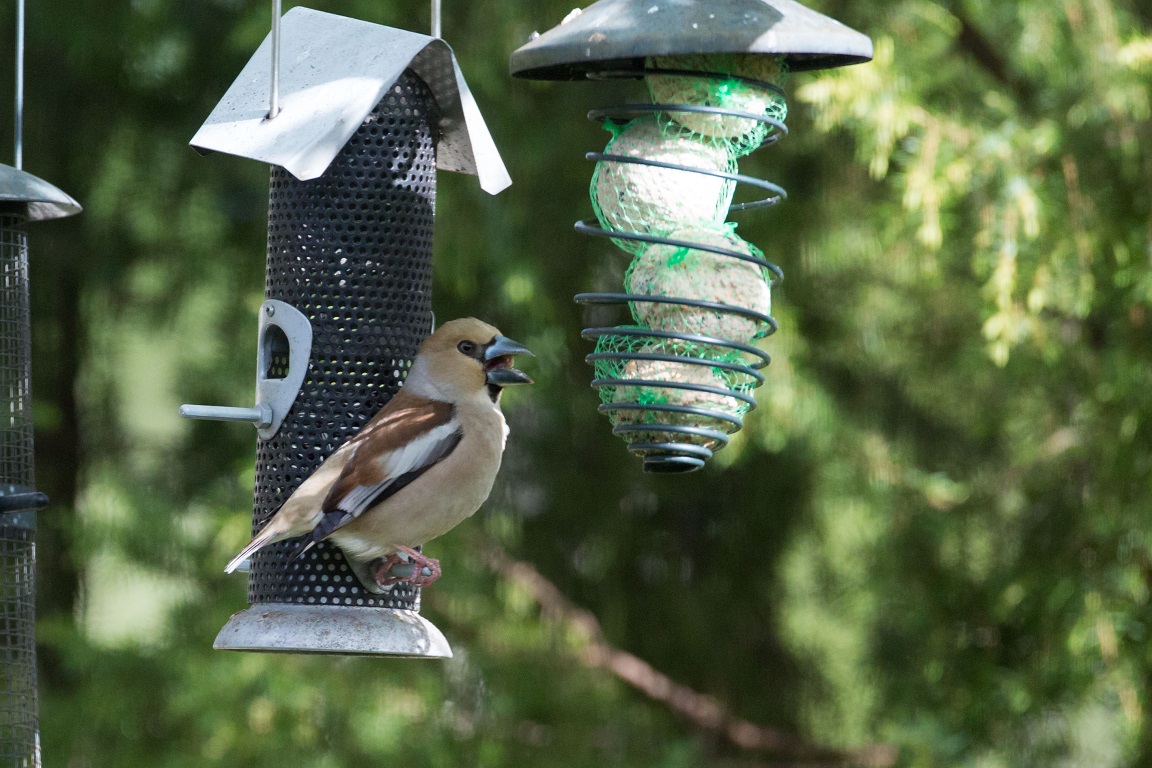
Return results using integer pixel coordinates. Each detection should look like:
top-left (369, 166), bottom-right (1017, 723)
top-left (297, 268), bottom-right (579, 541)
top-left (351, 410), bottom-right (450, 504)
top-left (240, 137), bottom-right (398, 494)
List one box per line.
top-left (212, 603), bottom-right (452, 659)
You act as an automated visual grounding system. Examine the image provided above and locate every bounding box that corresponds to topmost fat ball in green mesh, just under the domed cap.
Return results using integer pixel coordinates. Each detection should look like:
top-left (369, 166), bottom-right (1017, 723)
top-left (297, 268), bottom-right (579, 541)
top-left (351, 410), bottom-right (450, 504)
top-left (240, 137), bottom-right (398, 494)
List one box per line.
top-left (645, 53), bottom-right (788, 157)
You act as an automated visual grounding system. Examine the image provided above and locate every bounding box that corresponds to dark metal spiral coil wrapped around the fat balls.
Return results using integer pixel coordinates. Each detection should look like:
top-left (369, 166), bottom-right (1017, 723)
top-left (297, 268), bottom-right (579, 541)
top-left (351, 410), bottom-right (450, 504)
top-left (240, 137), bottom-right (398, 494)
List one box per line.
top-left (575, 68), bottom-right (788, 473)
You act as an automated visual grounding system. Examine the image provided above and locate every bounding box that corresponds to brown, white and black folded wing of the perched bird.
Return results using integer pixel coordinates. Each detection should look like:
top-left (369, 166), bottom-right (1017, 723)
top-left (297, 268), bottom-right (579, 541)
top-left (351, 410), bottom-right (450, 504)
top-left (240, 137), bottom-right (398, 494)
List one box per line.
top-left (312, 390), bottom-right (461, 541)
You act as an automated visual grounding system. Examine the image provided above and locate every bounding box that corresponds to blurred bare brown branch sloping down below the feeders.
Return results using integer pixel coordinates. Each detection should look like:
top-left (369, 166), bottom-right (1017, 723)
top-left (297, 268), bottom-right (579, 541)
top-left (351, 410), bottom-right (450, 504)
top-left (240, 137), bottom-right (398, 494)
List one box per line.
top-left (488, 552), bottom-right (897, 768)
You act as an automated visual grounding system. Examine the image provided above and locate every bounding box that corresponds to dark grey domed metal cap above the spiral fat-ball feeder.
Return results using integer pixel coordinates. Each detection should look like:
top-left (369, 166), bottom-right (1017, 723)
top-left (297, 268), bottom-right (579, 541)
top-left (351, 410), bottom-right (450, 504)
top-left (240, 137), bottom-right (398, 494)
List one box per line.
top-left (510, 0), bottom-right (872, 79)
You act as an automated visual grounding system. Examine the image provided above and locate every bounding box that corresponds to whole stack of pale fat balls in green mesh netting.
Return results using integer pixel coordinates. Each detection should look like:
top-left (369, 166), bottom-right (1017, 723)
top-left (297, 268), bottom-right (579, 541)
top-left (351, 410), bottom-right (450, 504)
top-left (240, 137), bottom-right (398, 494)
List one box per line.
top-left (590, 54), bottom-right (787, 455)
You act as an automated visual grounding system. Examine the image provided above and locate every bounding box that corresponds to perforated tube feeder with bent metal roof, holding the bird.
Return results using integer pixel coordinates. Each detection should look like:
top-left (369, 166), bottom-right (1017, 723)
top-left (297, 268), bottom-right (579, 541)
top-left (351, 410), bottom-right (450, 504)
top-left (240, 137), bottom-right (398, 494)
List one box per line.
top-left (181, 7), bottom-right (509, 657)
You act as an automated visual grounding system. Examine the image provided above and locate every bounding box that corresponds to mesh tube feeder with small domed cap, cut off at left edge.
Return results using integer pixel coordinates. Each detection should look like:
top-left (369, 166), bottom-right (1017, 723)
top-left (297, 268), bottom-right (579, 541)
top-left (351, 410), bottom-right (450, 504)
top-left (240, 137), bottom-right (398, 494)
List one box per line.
top-left (0, 163), bottom-right (81, 768)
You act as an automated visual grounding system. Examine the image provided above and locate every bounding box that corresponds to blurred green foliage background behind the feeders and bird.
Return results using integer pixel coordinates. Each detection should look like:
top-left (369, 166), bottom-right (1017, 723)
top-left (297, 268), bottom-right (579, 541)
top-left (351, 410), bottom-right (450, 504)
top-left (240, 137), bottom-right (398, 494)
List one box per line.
top-left (0, 0), bottom-right (1152, 768)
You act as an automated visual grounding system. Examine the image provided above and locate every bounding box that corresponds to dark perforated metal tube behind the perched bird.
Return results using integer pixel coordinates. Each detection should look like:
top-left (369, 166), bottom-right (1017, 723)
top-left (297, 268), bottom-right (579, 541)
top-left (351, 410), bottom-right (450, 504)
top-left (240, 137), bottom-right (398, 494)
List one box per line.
top-left (248, 70), bottom-right (438, 609)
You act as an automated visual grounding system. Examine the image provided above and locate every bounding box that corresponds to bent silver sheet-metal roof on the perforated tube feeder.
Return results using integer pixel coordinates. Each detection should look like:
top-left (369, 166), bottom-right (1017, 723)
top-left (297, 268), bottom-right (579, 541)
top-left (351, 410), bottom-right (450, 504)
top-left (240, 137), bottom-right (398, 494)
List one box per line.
top-left (190, 7), bottom-right (511, 195)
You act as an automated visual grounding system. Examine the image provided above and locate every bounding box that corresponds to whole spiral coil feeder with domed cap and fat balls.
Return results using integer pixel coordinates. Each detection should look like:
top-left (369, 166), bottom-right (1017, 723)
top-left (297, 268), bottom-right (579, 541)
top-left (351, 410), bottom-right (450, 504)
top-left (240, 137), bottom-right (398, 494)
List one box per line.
top-left (510, 0), bottom-right (872, 472)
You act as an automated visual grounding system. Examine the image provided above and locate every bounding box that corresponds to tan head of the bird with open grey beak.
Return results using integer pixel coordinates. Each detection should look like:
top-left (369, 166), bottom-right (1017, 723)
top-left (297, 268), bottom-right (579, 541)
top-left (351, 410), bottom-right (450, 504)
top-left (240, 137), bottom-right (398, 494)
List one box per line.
top-left (404, 318), bottom-right (532, 402)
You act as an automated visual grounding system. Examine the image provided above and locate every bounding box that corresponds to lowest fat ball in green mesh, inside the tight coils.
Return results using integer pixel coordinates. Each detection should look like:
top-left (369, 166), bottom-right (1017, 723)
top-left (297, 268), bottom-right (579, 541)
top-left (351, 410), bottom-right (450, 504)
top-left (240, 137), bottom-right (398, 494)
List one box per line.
top-left (596, 327), bottom-right (756, 448)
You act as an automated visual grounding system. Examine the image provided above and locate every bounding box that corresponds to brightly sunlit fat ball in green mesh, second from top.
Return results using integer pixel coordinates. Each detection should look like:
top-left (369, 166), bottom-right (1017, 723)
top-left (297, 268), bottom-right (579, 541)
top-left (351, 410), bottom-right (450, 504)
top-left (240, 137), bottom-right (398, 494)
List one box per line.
top-left (590, 115), bottom-right (736, 253)
